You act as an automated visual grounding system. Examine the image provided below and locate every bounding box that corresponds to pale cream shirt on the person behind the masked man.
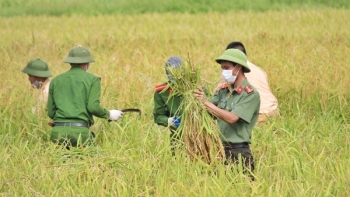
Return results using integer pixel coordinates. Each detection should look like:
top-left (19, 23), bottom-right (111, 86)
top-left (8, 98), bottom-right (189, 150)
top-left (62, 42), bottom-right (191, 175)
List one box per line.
top-left (244, 61), bottom-right (278, 114)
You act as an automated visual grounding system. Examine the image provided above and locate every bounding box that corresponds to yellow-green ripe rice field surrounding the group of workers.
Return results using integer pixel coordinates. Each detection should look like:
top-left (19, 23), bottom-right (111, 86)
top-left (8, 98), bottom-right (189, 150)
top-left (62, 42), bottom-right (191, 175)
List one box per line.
top-left (0, 8), bottom-right (350, 196)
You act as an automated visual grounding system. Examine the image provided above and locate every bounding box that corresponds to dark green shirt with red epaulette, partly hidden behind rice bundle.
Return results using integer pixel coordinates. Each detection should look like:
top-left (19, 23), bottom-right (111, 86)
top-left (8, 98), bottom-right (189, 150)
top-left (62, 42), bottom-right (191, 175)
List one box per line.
top-left (153, 83), bottom-right (182, 126)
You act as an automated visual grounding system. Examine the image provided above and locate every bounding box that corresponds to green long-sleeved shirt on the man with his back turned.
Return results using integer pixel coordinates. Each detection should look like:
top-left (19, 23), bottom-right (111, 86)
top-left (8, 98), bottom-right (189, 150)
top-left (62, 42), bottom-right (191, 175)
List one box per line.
top-left (47, 67), bottom-right (109, 125)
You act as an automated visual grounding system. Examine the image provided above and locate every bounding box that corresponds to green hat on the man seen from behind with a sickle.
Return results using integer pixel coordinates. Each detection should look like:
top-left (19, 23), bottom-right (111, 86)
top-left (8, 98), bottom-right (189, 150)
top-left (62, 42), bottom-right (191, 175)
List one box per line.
top-left (63, 45), bottom-right (95, 64)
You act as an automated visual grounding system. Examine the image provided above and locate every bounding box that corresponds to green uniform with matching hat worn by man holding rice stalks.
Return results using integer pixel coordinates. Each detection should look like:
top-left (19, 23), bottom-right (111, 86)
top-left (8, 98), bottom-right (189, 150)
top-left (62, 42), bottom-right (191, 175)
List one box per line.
top-left (210, 49), bottom-right (260, 174)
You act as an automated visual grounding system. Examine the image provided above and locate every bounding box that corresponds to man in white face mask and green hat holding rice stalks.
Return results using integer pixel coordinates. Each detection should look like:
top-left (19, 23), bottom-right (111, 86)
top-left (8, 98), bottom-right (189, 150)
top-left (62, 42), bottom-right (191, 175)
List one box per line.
top-left (194, 49), bottom-right (260, 171)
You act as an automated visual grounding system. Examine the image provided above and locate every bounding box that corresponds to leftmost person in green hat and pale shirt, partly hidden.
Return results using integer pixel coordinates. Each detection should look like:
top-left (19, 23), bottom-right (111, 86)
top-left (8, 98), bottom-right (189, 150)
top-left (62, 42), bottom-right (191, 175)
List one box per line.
top-left (22, 58), bottom-right (52, 114)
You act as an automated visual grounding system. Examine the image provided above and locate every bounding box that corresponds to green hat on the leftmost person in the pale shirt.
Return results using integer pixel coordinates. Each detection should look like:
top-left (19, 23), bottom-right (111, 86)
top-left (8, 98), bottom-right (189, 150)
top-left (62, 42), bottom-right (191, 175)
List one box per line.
top-left (22, 58), bottom-right (52, 77)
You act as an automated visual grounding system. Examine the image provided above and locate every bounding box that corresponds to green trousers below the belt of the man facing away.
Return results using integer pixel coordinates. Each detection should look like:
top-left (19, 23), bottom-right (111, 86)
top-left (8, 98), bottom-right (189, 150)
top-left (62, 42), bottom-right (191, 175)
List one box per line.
top-left (50, 126), bottom-right (95, 147)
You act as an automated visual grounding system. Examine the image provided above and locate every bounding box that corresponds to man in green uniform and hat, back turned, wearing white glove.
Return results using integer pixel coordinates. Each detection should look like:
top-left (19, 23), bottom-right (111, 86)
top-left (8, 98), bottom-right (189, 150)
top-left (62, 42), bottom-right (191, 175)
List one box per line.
top-left (47, 45), bottom-right (123, 149)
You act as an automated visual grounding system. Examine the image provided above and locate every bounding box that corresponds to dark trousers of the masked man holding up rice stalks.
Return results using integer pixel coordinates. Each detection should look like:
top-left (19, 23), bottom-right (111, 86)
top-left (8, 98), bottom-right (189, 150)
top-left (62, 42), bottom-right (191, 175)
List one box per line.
top-left (224, 144), bottom-right (254, 172)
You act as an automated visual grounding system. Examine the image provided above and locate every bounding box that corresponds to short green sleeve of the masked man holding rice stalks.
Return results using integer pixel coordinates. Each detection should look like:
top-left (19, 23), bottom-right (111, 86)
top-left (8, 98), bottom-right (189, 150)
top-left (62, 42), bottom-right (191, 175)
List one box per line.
top-left (232, 92), bottom-right (260, 123)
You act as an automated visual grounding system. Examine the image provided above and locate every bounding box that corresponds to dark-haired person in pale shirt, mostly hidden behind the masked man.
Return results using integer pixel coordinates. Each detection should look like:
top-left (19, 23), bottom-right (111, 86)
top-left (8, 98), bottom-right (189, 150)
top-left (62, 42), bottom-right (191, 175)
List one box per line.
top-left (213, 42), bottom-right (280, 123)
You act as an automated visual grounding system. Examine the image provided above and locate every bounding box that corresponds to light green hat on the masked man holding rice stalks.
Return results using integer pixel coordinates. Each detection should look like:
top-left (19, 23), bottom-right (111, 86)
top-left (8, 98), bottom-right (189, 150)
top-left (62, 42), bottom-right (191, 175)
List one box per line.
top-left (215, 49), bottom-right (250, 73)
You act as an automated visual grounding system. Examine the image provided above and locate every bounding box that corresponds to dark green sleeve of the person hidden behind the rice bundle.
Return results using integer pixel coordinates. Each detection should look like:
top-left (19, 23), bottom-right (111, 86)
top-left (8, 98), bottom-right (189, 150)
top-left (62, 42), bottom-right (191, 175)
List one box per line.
top-left (153, 92), bottom-right (169, 126)
